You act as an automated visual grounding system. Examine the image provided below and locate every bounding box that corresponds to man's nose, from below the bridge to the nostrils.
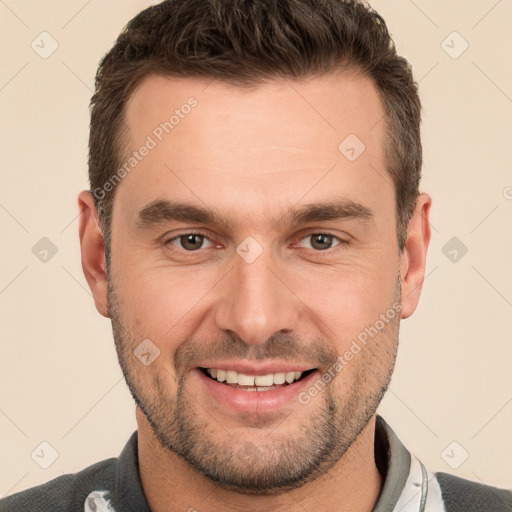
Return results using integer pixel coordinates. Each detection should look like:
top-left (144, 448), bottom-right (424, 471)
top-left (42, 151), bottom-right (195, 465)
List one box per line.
top-left (215, 251), bottom-right (302, 345)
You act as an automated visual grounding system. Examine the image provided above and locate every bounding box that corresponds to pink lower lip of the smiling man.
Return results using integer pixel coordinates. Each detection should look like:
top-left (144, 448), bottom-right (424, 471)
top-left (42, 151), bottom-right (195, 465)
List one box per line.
top-left (193, 368), bottom-right (318, 413)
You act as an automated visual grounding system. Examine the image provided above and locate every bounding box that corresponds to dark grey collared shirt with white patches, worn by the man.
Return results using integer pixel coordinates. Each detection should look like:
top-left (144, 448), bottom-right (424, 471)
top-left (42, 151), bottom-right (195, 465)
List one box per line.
top-left (0, 416), bottom-right (512, 512)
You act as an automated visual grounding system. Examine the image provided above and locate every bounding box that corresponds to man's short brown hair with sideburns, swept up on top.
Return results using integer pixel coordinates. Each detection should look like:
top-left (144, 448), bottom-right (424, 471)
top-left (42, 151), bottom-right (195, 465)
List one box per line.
top-left (89, 0), bottom-right (422, 261)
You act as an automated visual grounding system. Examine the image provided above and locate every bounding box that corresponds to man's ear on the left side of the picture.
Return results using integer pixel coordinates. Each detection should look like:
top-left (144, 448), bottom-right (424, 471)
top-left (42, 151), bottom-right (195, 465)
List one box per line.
top-left (78, 190), bottom-right (109, 318)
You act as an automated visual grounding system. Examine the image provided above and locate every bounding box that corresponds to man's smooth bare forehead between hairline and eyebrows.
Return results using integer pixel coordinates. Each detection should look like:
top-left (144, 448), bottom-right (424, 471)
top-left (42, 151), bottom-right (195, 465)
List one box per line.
top-left (114, 73), bottom-right (390, 228)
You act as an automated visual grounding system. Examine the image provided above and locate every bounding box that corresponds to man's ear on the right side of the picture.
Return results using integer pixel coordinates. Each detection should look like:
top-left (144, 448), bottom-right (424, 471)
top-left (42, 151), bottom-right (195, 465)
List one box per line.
top-left (400, 194), bottom-right (432, 318)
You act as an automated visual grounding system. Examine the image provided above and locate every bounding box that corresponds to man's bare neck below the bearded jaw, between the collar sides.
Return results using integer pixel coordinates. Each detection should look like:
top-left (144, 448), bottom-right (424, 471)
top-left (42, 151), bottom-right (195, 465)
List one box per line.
top-left (136, 407), bottom-right (382, 512)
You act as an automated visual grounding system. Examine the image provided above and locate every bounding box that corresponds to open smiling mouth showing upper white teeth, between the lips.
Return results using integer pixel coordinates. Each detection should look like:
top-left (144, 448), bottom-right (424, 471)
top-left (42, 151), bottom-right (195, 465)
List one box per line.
top-left (199, 367), bottom-right (316, 392)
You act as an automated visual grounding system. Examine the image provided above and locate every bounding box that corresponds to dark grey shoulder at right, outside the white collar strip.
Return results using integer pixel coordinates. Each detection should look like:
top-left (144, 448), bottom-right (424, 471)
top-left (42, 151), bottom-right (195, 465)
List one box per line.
top-left (436, 473), bottom-right (512, 512)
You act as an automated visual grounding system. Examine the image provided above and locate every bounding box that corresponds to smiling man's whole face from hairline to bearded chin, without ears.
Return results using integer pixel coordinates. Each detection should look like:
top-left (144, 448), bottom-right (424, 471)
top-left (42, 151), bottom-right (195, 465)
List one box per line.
top-left (87, 70), bottom-right (424, 494)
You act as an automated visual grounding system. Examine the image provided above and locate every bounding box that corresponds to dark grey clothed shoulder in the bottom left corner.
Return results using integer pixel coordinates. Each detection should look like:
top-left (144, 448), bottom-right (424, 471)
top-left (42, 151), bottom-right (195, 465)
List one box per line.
top-left (0, 458), bottom-right (117, 512)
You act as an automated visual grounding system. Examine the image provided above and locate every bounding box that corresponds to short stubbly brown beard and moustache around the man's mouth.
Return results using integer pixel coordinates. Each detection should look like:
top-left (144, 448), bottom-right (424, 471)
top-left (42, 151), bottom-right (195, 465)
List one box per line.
top-left (107, 278), bottom-right (401, 495)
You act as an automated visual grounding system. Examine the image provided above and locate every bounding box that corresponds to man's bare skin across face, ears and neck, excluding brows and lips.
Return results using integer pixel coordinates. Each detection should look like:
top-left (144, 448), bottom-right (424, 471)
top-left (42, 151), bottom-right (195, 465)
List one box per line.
top-left (79, 73), bottom-right (431, 512)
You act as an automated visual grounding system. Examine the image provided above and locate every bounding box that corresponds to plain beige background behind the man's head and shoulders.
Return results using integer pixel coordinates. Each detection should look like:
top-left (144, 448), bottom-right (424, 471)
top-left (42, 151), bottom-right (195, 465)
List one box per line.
top-left (0, 0), bottom-right (512, 495)
